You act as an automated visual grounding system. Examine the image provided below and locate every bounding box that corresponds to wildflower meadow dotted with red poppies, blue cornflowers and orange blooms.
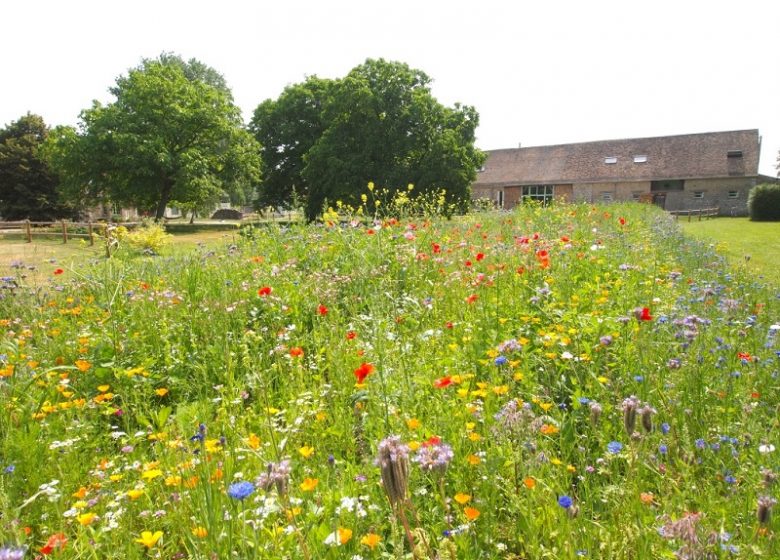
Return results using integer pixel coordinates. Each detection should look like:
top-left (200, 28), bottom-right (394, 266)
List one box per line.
top-left (0, 199), bottom-right (780, 560)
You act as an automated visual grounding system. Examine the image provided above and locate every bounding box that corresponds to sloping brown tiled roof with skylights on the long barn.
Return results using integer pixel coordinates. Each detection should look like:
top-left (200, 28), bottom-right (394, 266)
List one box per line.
top-left (474, 129), bottom-right (759, 187)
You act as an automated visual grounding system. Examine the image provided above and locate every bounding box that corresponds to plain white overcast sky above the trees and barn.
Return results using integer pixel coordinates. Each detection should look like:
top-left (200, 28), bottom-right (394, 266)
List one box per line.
top-left (0, 0), bottom-right (780, 175)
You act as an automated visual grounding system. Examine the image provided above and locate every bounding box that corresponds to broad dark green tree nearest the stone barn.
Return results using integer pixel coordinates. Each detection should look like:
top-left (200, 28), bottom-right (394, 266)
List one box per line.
top-left (250, 59), bottom-right (484, 219)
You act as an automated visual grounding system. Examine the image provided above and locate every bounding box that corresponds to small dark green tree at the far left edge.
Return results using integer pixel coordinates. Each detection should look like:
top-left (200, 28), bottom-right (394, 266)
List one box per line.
top-left (0, 113), bottom-right (72, 221)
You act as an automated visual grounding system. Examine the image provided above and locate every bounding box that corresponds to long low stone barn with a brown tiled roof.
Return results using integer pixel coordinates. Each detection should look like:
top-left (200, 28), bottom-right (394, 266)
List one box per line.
top-left (472, 130), bottom-right (773, 216)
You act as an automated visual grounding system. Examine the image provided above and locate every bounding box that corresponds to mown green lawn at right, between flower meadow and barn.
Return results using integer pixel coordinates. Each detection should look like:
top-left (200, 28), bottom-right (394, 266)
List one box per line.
top-left (680, 218), bottom-right (780, 278)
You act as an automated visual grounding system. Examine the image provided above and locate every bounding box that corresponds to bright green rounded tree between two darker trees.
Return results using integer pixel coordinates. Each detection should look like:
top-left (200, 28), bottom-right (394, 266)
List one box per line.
top-left (47, 54), bottom-right (261, 220)
